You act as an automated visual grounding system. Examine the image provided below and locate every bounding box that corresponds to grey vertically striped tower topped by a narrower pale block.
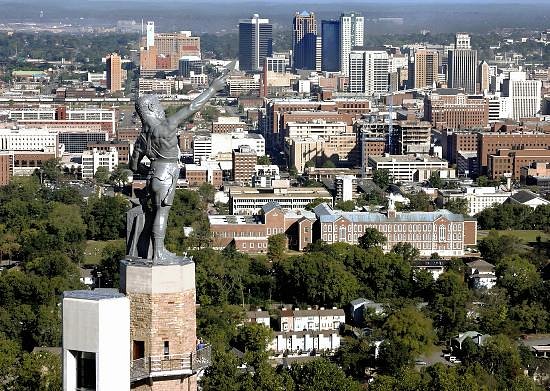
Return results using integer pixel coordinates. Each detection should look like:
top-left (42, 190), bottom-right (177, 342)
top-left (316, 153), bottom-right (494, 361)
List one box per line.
top-left (447, 33), bottom-right (477, 94)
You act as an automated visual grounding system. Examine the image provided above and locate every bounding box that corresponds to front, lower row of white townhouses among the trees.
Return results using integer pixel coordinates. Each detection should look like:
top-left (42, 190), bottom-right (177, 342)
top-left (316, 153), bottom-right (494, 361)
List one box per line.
top-left (268, 330), bottom-right (340, 354)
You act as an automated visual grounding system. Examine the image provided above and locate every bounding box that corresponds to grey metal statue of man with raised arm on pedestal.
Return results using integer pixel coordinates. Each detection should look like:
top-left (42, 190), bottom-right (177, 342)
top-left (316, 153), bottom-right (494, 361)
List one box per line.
top-left (127, 61), bottom-right (235, 263)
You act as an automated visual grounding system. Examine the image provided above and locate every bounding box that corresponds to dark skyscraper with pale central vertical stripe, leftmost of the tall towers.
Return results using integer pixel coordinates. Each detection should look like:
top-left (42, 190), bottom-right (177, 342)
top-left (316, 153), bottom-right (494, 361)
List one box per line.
top-left (239, 14), bottom-right (273, 71)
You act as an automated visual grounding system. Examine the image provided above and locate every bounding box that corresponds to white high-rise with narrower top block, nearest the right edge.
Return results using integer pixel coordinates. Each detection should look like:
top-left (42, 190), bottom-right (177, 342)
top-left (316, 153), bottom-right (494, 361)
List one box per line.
top-left (503, 72), bottom-right (542, 121)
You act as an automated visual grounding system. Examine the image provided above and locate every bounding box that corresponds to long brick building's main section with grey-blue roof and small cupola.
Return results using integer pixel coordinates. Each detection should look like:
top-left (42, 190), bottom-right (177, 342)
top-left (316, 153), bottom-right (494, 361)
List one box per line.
top-left (313, 204), bottom-right (477, 256)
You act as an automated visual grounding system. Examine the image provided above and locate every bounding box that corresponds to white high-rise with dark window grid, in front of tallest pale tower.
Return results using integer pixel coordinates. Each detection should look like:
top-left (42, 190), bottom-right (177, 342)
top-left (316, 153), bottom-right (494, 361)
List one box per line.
top-left (349, 50), bottom-right (389, 95)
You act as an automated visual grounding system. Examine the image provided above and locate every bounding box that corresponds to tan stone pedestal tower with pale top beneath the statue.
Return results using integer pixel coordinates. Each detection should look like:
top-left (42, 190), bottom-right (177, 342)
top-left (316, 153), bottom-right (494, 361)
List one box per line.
top-left (120, 257), bottom-right (210, 391)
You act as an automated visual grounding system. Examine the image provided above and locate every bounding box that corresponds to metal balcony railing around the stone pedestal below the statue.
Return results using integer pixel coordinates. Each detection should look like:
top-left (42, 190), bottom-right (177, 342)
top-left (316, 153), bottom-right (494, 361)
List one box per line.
top-left (130, 345), bottom-right (212, 381)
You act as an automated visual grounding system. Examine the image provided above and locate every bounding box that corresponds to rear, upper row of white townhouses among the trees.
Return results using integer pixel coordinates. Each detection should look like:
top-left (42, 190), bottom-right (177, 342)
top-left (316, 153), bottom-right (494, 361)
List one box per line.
top-left (280, 307), bottom-right (346, 331)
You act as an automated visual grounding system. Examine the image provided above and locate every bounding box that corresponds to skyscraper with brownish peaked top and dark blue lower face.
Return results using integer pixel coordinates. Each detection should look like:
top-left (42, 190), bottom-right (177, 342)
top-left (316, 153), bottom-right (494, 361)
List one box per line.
top-left (292, 11), bottom-right (317, 69)
